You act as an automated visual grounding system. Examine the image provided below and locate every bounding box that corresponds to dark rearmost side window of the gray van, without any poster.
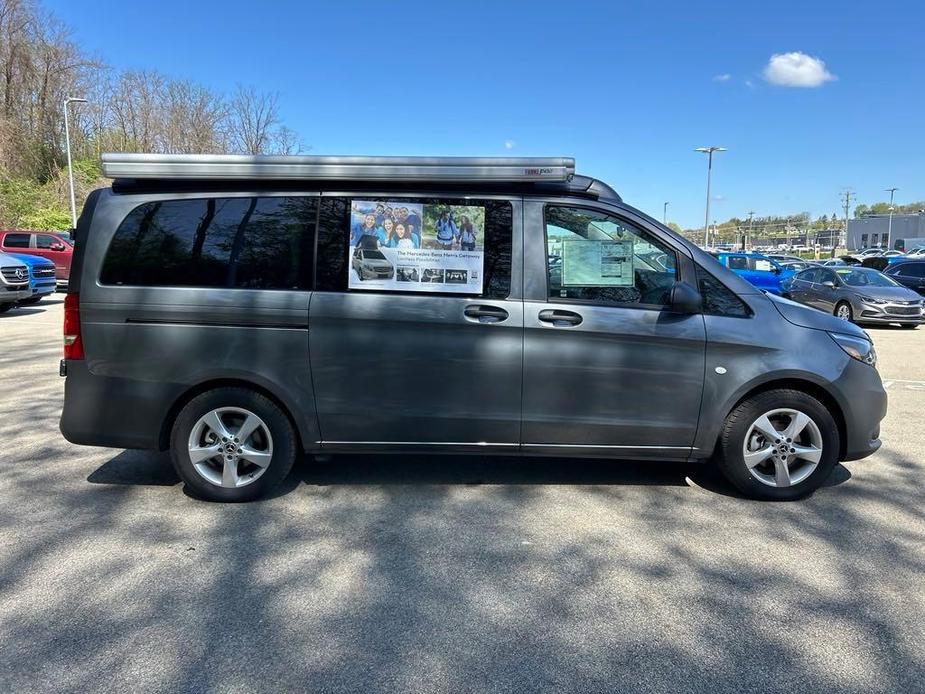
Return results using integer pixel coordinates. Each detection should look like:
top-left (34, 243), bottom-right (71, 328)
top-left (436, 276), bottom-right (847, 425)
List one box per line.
top-left (100, 196), bottom-right (318, 289)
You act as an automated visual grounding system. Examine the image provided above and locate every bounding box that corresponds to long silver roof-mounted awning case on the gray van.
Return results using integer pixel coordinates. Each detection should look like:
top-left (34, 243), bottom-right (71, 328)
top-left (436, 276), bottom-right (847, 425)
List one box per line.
top-left (102, 153), bottom-right (575, 182)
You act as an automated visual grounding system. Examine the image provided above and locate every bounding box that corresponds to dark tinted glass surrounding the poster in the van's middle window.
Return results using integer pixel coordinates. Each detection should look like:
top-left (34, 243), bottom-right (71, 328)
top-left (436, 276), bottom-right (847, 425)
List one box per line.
top-left (315, 195), bottom-right (514, 299)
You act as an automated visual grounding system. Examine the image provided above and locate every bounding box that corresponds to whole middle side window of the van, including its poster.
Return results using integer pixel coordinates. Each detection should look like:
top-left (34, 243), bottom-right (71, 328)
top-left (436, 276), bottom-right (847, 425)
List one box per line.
top-left (315, 196), bottom-right (514, 299)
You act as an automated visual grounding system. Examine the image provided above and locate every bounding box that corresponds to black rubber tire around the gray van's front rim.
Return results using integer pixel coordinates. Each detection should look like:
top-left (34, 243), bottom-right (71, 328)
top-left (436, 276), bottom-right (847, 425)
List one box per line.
top-left (717, 389), bottom-right (840, 501)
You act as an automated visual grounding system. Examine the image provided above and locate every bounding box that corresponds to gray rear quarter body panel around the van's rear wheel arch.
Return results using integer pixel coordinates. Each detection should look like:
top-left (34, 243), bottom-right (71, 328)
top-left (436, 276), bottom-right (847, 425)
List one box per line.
top-left (61, 191), bottom-right (319, 448)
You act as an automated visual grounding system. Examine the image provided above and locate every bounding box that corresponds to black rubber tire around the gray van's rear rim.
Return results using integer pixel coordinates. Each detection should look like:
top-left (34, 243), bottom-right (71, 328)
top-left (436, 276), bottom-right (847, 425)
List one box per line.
top-left (170, 388), bottom-right (297, 502)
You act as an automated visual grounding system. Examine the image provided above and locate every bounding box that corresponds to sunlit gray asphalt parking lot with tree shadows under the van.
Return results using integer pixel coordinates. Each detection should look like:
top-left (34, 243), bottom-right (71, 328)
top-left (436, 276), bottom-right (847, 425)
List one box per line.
top-left (0, 302), bottom-right (925, 694)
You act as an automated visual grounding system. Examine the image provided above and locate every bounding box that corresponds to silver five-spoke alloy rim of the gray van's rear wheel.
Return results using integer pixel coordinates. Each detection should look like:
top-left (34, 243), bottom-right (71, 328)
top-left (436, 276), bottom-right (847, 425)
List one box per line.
top-left (188, 407), bottom-right (273, 488)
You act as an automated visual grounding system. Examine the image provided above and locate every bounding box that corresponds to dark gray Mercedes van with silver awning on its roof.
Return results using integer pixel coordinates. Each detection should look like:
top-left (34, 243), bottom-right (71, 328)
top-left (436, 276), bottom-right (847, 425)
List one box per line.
top-left (61, 154), bottom-right (886, 501)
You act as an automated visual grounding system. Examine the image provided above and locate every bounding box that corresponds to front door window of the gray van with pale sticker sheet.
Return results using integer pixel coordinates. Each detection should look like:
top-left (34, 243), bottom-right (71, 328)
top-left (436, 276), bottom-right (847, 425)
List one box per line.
top-left (546, 205), bottom-right (677, 306)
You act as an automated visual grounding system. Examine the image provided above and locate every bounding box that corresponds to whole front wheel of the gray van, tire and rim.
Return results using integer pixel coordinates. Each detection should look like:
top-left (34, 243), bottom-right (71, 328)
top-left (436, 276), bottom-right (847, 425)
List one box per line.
top-left (718, 389), bottom-right (839, 501)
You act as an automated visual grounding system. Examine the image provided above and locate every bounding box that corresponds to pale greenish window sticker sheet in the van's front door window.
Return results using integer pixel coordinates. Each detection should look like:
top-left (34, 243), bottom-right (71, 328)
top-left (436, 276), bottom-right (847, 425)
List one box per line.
top-left (561, 239), bottom-right (635, 287)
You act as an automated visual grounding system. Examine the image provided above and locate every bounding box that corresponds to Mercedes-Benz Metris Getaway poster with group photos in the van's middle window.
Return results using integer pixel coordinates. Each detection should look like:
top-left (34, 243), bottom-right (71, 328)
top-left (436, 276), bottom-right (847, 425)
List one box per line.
top-left (347, 200), bottom-right (485, 294)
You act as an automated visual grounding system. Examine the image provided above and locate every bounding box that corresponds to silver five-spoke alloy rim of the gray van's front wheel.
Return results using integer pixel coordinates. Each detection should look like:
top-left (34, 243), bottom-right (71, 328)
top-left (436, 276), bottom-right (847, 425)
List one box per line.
top-left (742, 408), bottom-right (822, 487)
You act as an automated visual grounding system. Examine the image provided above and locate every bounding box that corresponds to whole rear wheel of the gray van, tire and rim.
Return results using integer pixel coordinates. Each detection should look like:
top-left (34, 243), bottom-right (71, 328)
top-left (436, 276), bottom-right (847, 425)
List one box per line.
top-left (170, 388), bottom-right (296, 502)
